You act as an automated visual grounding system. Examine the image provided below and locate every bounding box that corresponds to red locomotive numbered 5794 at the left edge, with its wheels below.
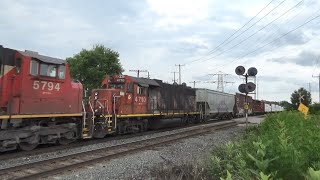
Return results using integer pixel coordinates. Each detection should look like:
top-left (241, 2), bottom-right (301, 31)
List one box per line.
top-left (0, 46), bottom-right (82, 152)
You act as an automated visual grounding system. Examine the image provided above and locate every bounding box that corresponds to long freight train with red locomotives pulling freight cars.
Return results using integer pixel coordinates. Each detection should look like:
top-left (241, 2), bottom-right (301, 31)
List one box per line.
top-left (0, 46), bottom-right (282, 152)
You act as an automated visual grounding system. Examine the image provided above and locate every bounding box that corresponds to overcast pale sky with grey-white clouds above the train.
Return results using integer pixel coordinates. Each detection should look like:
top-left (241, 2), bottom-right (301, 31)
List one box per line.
top-left (0, 0), bottom-right (320, 102)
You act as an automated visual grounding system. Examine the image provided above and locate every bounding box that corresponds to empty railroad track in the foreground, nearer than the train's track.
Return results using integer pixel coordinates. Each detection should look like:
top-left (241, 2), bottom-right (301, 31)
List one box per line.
top-left (0, 121), bottom-right (237, 179)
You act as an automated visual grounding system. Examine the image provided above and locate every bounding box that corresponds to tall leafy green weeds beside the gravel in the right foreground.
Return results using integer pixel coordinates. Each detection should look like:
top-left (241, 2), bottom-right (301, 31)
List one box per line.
top-left (209, 112), bottom-right (320, 179)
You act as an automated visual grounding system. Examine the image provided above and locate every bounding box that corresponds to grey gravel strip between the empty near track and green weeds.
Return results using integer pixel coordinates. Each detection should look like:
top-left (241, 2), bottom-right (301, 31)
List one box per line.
top-left (52, 126), bottom-right (245, 180)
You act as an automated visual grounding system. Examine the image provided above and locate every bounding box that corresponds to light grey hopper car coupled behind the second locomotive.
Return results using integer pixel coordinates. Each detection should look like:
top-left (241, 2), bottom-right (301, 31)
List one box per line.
top-left (196, 89), bottom-right (235, 119)
